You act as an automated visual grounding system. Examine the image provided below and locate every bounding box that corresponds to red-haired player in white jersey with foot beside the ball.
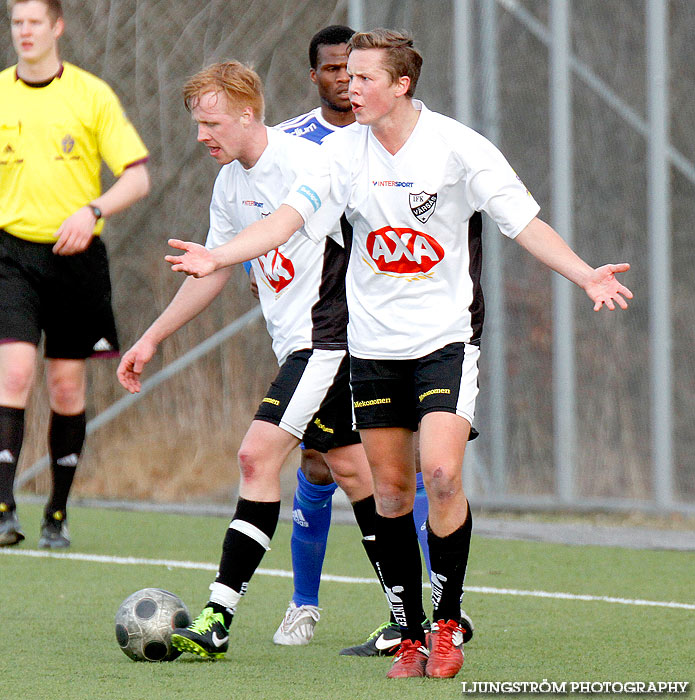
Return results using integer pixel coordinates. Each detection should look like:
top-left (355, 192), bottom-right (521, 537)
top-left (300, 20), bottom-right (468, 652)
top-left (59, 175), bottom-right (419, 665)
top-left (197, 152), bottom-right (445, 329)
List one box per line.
top-left (118, 61), bottom-right (375, 658)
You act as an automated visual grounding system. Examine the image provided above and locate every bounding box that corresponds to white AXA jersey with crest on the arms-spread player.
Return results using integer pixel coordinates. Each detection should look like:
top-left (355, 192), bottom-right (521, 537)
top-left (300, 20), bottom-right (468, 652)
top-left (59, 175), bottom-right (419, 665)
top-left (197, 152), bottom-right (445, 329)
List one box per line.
top-left (285, 100), bottom-right (539, 359)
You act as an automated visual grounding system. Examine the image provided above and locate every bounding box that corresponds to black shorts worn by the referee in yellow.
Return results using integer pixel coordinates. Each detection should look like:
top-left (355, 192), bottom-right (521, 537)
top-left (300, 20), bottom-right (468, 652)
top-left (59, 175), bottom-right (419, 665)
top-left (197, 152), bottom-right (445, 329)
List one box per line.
top-left (0, 229), bottom-right (118, 360)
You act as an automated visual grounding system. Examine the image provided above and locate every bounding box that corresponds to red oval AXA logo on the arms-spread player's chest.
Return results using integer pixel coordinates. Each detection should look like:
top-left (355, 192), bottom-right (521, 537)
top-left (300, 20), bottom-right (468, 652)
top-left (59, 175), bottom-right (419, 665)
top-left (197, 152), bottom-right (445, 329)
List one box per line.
top-left (367, 226), bottom-right (444, 275)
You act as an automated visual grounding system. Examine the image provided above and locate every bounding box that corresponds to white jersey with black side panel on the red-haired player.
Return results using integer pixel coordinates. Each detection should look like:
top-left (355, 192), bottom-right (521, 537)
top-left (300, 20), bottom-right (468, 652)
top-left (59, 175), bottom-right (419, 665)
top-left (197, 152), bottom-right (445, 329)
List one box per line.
top-left (205, 129), bottom-right (347, 365)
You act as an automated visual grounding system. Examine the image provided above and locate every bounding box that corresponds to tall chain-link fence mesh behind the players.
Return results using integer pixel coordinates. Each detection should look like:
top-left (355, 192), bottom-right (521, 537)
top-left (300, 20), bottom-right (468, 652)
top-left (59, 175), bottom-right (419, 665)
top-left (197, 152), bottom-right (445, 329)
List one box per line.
top-left (0, 0), bottom-right (695, 516)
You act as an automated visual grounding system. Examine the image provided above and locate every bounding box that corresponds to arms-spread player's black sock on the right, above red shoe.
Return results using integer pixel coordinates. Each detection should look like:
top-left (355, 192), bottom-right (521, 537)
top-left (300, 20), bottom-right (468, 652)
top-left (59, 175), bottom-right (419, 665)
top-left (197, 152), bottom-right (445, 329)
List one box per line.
top-left (427, 506), bottom-right (473, 622)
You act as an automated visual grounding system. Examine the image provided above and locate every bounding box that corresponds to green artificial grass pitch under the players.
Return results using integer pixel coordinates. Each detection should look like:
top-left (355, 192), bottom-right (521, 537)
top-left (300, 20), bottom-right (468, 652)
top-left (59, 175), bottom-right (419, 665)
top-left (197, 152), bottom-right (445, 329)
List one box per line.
top-left (0, 504), bottom-right (695, 700)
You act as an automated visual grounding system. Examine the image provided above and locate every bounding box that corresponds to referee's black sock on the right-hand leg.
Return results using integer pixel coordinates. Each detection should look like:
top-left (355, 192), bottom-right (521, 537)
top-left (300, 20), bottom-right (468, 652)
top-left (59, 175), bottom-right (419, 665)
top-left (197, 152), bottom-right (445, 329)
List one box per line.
top-left (45, 411), bottom-right (87, 517)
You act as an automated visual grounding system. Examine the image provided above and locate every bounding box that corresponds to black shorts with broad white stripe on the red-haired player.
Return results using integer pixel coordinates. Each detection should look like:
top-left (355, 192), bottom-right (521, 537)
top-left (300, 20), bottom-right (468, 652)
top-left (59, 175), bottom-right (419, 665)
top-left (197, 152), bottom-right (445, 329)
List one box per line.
top-left (254, 350), bottom-right (360, 452)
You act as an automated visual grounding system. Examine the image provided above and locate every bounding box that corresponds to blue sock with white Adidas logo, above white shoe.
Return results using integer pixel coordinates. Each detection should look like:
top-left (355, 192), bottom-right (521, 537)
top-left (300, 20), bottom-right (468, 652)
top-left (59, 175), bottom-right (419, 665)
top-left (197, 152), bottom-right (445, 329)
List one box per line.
top-left (290, 469), bottom-right (338, 606)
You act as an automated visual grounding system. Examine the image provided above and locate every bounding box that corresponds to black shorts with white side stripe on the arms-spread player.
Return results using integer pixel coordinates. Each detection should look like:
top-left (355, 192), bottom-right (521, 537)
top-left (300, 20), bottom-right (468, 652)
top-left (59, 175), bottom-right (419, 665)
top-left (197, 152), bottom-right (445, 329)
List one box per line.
top-left (350, 343), bottom-right (480, 439)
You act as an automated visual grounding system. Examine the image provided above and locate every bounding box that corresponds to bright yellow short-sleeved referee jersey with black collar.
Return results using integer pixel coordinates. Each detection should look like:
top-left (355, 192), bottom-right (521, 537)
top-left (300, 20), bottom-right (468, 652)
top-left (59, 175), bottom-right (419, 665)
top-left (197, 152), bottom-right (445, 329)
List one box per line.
top-left (0, 63), bottom-right (148, 243)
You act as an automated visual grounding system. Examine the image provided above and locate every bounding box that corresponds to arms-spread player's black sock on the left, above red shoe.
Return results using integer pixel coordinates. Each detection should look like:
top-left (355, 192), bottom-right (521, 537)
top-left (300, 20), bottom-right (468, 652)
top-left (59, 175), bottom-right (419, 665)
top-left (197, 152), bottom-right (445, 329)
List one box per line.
top-left (376, 511), bottom-right (425, 644)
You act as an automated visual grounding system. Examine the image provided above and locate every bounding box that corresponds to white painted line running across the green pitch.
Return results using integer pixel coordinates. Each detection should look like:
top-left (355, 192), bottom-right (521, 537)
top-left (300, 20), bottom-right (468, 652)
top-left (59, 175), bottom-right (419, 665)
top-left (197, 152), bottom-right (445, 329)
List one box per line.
top-left (0, 549), bottom-right (695, 610)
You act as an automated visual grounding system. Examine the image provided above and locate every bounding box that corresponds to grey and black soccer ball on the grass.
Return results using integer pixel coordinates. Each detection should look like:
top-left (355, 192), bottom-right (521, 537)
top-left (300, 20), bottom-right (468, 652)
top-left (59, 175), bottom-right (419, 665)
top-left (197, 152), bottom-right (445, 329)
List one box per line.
top-left (116, 588), bottom-right (191, 661)
